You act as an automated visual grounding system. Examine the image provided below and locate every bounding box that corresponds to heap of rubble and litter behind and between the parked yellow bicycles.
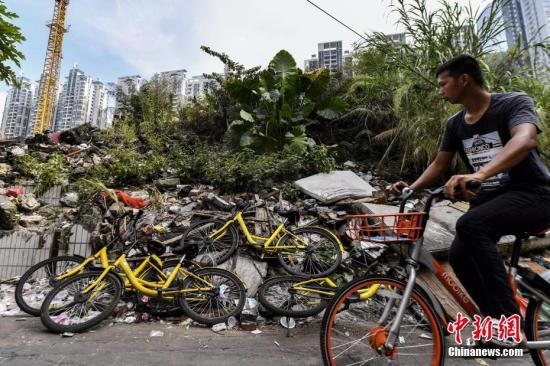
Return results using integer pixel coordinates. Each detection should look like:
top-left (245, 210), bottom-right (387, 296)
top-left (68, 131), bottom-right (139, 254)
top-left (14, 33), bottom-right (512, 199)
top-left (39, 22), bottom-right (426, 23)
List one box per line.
top-left (0, 125), bottom-right (550, 332)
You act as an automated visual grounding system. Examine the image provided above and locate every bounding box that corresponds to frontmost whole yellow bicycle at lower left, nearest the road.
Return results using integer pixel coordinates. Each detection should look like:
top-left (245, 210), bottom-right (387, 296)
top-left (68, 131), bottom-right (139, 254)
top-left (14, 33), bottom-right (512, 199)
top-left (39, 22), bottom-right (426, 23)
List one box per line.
top-left (40, 239), bottom-right (246, 333)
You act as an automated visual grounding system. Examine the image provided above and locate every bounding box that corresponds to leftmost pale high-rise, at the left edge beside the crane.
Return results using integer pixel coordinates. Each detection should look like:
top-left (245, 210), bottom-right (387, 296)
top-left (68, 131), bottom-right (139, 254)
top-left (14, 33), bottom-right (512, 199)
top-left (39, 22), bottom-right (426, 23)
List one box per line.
top-left (2, 77), bottom-right (36, 139)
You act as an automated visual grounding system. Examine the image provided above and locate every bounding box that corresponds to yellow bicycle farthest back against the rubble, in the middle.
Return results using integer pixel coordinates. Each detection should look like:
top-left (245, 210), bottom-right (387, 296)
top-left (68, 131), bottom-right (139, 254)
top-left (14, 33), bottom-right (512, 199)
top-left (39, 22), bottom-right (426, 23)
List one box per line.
top-left (172, 204), bottom-right (344, 277)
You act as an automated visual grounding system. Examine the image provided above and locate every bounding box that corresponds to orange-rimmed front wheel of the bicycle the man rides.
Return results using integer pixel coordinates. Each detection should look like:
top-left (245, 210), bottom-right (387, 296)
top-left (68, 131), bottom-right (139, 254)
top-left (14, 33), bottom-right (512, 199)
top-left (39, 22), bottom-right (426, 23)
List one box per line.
top-left (321, 276), bottom-right (445, 366)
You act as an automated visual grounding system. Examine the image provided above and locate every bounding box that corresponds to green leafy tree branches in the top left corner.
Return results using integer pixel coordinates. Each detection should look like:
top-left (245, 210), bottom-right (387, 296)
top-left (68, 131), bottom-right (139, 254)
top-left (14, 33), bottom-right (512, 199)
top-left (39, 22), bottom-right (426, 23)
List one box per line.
top-left (0, 0), bottom-right (26, 85)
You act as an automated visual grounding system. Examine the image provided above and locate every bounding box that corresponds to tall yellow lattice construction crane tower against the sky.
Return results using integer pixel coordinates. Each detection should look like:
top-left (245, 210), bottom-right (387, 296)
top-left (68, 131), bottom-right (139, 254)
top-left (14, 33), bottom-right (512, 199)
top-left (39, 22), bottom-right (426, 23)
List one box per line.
top-left (33, 0), bottom-right (69, 133)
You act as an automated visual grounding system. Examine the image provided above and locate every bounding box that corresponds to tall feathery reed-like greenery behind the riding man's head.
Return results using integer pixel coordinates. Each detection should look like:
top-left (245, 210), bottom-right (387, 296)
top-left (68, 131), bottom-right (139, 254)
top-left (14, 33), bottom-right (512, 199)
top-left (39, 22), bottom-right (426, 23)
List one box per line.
top-left (360, 0), bottom-right (546, 170)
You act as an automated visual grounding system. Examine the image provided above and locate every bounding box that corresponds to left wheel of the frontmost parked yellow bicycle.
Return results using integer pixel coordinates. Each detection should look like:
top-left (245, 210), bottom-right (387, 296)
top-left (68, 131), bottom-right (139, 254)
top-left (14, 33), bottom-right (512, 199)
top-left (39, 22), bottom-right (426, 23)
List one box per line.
top-left (40, 271), bottom-right (122, 333)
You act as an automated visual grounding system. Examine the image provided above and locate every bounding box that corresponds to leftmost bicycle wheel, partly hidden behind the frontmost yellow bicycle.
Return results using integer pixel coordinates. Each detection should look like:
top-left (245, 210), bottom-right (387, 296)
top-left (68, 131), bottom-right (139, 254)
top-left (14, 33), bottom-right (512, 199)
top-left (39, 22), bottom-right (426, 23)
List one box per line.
top-left (15, 255), bottom-right (85, 316)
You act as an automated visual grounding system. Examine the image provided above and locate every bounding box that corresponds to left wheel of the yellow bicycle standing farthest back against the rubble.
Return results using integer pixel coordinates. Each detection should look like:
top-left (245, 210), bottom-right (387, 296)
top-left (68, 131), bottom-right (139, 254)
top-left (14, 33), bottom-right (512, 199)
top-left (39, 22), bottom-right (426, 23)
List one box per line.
top-left (179, 219), bottom-right (239, 265)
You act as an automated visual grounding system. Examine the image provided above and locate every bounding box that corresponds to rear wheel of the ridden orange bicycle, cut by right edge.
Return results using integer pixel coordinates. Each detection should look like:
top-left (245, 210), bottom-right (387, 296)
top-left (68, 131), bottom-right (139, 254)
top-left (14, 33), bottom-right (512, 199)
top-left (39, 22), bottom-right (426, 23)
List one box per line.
top-left (525, 299), bottom-right (550, 366)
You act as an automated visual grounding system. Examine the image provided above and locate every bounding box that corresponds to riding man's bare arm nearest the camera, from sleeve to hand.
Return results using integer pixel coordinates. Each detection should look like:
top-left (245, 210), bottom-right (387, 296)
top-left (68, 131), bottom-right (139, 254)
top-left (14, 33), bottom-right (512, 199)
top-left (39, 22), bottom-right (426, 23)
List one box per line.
top-left (445, 123), bottom-right (537, 198)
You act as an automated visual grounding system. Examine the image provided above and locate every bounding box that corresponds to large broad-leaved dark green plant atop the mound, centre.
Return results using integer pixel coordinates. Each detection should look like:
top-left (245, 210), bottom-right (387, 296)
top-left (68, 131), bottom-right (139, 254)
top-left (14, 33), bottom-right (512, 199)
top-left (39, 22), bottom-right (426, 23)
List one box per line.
top-left (223, 50), bottom-right (347, 154)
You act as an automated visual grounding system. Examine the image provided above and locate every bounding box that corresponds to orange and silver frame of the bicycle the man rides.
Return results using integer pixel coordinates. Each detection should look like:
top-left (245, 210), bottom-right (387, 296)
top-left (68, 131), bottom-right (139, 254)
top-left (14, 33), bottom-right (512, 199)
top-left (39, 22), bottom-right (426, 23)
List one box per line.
top-left (381, 193), bottom-right (550, 349)
